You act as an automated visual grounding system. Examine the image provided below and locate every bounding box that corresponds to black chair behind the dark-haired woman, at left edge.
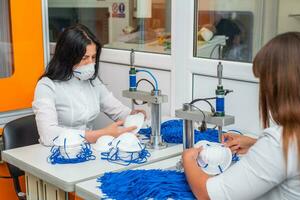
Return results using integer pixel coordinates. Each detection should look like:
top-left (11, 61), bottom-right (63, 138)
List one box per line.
top-left (2, 115), bottom-right (39, 200)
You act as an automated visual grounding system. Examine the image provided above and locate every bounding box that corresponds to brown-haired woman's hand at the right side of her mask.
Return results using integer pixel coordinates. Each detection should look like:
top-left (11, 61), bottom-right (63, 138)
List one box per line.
top-left (222, 133), bottom-right (256, 154)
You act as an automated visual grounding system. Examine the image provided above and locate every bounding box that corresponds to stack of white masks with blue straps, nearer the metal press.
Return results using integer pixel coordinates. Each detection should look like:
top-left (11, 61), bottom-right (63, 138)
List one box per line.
top-left (101, 133), bottom-right (150, 166)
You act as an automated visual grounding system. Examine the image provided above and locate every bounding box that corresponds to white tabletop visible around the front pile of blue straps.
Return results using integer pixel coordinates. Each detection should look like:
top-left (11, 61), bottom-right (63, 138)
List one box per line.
top-left (75, 156), bottom-right (181, 200)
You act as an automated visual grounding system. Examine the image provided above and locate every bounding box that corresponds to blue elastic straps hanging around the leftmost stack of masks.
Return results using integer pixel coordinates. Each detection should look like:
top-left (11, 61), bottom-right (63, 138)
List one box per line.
top-left (48, 141), bottom-right (96, 165)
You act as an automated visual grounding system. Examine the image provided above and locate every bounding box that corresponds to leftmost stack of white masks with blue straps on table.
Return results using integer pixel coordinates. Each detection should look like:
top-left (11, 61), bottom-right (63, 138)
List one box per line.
top-left (48, 132), bottom-right (96, 164)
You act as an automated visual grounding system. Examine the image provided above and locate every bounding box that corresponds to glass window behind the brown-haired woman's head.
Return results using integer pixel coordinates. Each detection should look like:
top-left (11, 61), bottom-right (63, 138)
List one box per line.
top-left (193, 0), bottom-right (300, 62)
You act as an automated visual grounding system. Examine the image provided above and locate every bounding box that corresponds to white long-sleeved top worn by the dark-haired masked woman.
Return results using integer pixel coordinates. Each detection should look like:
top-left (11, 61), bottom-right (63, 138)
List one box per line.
top-left (32, 77), bottom-right (131, 146)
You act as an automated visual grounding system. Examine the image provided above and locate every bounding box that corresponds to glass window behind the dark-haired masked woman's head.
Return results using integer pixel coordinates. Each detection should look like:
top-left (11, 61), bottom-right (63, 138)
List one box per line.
top-left (48, 0), bottom-right (171, 54)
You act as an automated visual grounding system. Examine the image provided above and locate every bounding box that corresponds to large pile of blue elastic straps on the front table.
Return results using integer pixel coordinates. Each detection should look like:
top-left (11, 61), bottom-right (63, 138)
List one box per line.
top-left (97, 169), bottom-right (196, 200)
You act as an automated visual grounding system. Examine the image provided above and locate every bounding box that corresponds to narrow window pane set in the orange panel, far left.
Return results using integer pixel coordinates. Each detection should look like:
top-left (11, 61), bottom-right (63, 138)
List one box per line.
top-left (0, 0), bottom-right (14, 78)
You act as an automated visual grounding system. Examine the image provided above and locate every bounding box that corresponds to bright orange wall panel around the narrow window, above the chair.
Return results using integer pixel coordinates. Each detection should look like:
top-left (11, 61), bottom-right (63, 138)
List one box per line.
top-left (0, 0), bottom-right (44, 112)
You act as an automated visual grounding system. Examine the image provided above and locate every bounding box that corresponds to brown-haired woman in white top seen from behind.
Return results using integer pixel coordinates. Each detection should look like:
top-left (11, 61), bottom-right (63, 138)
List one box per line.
top-left (183, 32), bottom-right (300, 200)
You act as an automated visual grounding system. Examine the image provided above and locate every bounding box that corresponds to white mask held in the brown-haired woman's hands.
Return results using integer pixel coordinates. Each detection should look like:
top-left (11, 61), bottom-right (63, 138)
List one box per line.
top-left (195, 141), bottom-right (232, 175)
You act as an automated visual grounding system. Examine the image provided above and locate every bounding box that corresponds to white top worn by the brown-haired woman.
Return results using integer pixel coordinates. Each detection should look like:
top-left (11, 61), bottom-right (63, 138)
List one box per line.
top-left (206, 126), bottom-right (300, 200)
